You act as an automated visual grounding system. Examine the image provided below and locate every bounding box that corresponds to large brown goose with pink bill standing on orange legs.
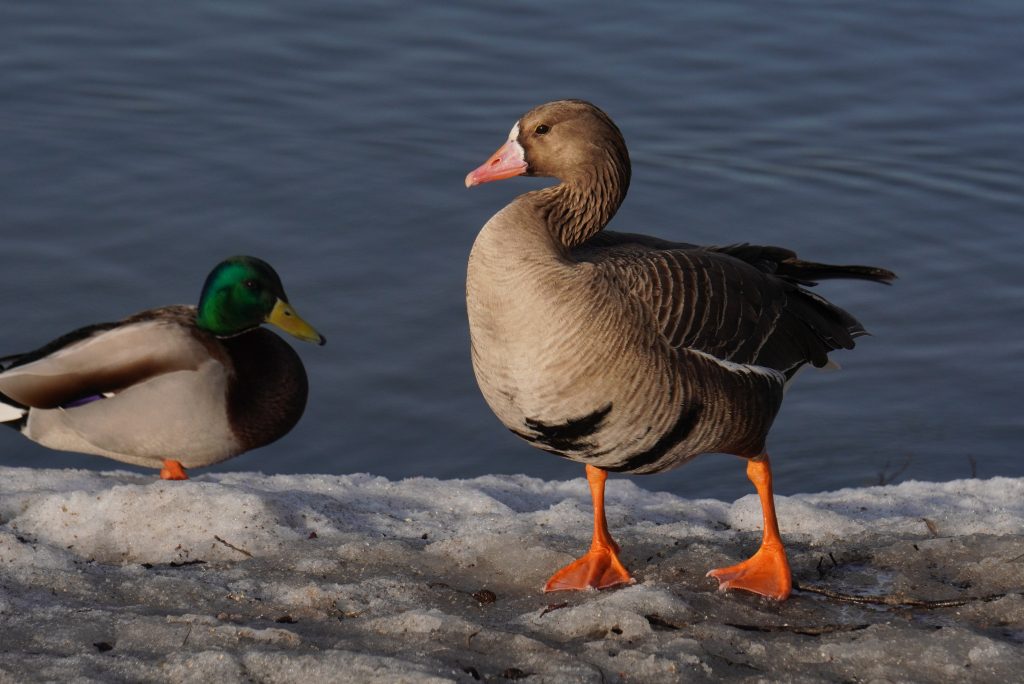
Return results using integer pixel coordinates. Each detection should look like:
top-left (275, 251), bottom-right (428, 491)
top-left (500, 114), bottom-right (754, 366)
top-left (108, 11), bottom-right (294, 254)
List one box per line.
top-left (466, 100), bottom-right (895, 600)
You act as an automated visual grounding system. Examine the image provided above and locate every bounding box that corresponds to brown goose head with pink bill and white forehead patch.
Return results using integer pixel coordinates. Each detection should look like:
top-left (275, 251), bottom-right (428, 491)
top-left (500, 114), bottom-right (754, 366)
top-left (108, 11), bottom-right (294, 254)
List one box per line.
top-left (466, 99), bottom-right (630, 189)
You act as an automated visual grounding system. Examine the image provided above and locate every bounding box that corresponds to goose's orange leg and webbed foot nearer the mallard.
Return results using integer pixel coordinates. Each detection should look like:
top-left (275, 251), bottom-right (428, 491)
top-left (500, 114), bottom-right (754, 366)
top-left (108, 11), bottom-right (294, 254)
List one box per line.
top-left (544, 466), bottom-right (634, 592)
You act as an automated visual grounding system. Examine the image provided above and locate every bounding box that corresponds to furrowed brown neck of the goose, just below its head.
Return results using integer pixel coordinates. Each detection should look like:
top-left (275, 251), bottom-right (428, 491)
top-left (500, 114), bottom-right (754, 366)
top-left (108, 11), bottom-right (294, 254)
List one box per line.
top-left (531, 147), bottom-right (630, 249)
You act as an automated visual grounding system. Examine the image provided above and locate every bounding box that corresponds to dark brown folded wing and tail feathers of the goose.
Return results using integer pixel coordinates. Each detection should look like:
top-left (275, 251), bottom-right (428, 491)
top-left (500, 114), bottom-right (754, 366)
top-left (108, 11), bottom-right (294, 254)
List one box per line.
top-left (573, 231), bottom-right (895, 375)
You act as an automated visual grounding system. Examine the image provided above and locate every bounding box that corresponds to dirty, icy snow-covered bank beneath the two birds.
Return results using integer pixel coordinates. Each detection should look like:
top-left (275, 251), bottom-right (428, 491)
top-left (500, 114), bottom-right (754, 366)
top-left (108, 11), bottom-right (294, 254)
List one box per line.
top-left (0, 468), bottom-right (1024, 684)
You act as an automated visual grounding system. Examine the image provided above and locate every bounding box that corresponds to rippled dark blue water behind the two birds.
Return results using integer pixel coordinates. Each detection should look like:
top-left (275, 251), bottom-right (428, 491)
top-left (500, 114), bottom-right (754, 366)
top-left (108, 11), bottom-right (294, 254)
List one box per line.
top-left (0, 0), bottom-right (1024, 498)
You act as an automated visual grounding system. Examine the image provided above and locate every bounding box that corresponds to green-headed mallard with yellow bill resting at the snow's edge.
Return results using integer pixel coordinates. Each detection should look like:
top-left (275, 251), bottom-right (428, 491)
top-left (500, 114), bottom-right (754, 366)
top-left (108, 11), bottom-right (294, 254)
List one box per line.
top-left (0, 256), bottom-right (326, 479)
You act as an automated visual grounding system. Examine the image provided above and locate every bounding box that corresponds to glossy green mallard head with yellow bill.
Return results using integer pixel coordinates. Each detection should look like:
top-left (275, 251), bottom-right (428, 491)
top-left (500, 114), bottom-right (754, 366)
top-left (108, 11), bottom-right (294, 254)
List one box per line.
top-left (196, 256), bottom-right (327, 344)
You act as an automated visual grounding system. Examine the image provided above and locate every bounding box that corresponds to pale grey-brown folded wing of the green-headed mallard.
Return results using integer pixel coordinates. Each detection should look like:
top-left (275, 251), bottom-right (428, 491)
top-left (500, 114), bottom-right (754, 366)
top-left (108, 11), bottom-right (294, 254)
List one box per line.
top-left (0, 317), bottom-right (211, 409)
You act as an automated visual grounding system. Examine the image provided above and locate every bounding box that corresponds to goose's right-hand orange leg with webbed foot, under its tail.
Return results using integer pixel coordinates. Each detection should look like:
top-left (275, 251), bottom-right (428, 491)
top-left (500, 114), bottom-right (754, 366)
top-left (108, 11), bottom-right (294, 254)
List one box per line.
top-left (708, 454), bottom-right (793, 601)
